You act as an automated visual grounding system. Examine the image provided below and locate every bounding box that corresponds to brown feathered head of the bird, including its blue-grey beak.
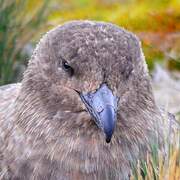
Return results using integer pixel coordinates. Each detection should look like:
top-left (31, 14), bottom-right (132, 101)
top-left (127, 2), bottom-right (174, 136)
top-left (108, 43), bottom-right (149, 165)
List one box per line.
top-left (16, 21), bottom-right (158, 146)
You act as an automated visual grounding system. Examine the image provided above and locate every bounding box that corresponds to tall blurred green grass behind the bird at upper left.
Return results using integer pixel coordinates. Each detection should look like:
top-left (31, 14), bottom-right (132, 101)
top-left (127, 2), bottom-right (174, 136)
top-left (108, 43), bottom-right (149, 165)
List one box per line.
top-left (0, 0), bottom-right (48, 85)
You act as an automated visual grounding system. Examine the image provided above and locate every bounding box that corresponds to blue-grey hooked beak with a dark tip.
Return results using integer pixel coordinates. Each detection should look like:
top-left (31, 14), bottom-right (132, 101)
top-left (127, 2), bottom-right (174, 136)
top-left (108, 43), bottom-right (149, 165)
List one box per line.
top-left (79, 84), bottom-right (118, 143)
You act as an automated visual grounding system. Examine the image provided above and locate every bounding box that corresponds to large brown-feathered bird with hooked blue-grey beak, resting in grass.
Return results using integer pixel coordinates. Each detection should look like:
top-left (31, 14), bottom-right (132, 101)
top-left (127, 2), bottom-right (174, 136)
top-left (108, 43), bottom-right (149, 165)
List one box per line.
top-left (0, 20), bottom-right (178, 180)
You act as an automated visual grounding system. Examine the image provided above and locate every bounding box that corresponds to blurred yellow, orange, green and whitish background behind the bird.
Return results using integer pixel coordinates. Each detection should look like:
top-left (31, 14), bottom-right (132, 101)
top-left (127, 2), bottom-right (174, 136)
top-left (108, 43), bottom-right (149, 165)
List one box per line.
top-left (0, 0), bottom-right (180, 115)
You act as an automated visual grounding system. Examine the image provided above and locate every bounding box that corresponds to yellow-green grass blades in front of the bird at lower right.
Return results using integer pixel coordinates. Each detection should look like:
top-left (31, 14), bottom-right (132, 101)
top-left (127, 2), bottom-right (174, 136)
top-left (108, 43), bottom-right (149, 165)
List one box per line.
top-left (130, 119), bottom-right (180, 180)
